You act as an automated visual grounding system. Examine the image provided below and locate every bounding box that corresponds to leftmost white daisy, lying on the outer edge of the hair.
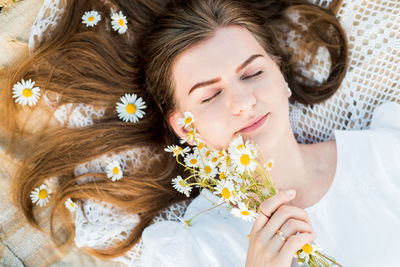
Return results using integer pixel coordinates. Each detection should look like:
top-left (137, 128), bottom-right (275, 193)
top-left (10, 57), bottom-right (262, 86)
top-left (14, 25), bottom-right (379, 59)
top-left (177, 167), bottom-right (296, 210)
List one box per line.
top-left (13, 79), bottom-right (40, 106)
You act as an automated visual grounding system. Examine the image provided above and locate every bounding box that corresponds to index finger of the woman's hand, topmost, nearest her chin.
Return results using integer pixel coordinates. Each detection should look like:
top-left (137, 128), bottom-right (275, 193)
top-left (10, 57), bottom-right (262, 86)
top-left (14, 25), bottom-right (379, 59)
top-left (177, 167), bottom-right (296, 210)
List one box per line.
top-left (250, 191), bottom-right (296, 234)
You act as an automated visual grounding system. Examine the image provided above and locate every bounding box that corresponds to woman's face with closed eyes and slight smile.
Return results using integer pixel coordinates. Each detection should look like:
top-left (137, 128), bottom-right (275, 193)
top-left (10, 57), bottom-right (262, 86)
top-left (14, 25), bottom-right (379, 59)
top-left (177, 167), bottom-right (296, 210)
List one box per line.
top-left (169, 26), bottom-right (291, 152)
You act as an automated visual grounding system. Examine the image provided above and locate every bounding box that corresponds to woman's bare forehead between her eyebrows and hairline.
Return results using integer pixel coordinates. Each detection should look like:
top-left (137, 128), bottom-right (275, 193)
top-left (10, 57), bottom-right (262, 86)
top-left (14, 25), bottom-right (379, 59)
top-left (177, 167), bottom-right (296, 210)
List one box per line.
top-left (172, 26), bottom-right (267, 90)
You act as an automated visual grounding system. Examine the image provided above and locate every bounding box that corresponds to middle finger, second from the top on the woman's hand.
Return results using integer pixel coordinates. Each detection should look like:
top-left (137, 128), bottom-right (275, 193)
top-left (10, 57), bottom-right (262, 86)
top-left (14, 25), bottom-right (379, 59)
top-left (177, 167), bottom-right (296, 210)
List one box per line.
top-left (260, 205), bottom-right (311, 239)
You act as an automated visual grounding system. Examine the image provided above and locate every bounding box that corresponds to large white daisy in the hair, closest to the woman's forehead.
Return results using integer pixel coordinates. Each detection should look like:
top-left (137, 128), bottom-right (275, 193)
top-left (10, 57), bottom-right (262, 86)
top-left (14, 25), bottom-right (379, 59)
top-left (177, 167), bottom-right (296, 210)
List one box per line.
top-left (117, 94), bottom-right (146, 122)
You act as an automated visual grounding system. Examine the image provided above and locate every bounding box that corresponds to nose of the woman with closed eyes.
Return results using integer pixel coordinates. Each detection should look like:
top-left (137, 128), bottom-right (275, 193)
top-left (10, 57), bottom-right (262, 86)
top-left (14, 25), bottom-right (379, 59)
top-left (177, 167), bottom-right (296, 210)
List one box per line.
top-left (230, 84), bottom-right (257, 115)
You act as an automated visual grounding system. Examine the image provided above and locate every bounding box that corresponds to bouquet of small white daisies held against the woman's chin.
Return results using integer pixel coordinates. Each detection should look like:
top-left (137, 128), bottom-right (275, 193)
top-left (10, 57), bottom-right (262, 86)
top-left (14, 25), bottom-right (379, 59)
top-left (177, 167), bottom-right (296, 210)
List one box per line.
top-left (165, 112), bottom-right (341, 267)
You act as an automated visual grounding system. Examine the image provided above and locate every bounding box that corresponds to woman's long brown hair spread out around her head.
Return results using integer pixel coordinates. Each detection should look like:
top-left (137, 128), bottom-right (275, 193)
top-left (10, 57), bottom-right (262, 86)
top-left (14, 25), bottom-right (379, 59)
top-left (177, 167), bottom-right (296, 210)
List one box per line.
top-left (1, 0), bottom-right (347, 258)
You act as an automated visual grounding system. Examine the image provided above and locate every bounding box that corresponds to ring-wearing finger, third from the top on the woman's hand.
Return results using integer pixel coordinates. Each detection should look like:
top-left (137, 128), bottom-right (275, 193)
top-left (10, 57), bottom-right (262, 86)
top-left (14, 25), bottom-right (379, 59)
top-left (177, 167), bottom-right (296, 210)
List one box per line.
top-left (268, 219), bottom-right (314, 253)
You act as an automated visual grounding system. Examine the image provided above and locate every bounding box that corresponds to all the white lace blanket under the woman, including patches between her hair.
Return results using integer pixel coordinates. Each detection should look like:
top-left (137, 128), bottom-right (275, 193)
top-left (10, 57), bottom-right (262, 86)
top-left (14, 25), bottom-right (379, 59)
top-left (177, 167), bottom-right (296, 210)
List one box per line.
top-left (29, 0), bottom-right (400, 266)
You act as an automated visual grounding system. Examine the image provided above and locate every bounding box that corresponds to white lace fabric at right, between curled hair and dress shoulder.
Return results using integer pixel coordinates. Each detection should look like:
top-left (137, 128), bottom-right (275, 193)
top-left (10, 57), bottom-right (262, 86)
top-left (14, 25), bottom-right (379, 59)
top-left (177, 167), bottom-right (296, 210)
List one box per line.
top-left (290, 0), bottom-right (400, 143)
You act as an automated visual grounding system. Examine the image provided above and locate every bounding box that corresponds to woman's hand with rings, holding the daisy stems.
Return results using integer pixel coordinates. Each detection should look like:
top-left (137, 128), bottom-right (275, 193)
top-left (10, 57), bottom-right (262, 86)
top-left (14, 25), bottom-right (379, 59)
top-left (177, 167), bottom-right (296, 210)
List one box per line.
top-left (246, 190), bottom-right (316, 267)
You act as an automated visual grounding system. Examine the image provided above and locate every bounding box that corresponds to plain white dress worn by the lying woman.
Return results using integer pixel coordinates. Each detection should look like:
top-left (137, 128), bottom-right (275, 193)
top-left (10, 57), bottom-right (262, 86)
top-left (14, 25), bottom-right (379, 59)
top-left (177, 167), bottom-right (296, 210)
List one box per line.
top-left (138, 103), bottom-right (400, 267)
